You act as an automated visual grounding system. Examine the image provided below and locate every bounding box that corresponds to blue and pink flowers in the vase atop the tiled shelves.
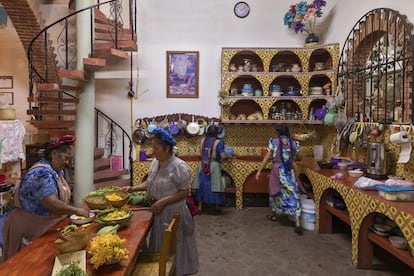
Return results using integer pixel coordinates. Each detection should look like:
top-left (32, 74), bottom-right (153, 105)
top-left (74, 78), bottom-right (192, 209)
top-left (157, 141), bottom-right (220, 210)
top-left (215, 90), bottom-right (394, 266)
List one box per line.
top-left (283, 0), bottom-right (326, 34)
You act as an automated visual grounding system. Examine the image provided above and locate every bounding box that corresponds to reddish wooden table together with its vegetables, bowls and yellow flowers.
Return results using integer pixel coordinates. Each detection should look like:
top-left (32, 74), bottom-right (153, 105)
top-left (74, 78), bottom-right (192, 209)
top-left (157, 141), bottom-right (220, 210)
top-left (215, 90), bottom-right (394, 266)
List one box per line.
top-left (0, 188), bottom-right (152, 275)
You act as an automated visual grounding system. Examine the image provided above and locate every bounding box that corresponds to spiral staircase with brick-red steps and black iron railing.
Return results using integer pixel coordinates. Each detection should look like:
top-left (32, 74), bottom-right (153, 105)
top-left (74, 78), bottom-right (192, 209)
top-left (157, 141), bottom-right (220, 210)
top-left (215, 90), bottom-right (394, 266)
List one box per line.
top-left (0, 0), bottom-right (137, 187)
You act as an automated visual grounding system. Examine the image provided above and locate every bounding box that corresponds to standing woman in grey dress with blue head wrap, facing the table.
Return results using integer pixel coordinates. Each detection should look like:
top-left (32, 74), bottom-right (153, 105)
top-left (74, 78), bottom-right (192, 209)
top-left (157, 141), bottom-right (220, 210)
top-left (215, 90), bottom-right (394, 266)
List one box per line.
top-left (127, 127), bottom-right (199, 276)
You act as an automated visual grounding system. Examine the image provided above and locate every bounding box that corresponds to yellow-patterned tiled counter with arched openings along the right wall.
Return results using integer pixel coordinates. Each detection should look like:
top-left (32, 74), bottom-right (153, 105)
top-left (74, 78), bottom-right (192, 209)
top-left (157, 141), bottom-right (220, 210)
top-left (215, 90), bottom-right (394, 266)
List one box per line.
top-left (295, 157), bottom-right (414, 269)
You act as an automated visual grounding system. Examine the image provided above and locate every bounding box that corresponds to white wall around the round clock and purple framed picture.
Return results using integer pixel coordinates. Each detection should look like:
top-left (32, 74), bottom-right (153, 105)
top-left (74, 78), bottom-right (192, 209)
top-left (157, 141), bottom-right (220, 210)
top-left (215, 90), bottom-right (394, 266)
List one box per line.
top-left (96, 0), bottom-right (414, 134)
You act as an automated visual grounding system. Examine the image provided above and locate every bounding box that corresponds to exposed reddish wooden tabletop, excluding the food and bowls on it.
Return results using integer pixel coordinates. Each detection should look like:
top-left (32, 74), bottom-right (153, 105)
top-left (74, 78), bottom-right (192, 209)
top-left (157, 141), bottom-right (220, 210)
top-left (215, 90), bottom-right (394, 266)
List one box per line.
top-left (0, 210), bottom-right (152, 276)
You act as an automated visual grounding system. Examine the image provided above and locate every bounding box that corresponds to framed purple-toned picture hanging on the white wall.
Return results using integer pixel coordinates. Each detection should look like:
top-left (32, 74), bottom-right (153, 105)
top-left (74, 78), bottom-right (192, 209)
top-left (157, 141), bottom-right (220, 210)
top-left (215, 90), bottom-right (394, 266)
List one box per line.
top-left (167, 51), bottom-right (199, 98)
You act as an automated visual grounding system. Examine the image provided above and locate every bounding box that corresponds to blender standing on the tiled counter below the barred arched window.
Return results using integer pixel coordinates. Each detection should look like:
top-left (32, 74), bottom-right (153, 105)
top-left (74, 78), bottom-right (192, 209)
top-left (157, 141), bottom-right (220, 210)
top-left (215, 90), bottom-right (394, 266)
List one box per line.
top-left (367, 143), bottom-right (387, 179)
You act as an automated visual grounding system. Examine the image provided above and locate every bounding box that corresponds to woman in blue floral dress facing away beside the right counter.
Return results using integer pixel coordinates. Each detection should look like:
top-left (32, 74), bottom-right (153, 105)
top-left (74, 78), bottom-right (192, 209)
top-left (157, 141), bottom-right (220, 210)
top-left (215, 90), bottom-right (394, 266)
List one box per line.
top-left (256, 125), bottom-right (302, 235)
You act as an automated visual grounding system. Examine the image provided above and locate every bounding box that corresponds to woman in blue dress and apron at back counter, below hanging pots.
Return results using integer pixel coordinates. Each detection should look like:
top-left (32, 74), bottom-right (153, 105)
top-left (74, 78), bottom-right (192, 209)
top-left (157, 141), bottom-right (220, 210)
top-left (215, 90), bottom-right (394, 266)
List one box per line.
top-left (193, 125), bottom-right (227, 213)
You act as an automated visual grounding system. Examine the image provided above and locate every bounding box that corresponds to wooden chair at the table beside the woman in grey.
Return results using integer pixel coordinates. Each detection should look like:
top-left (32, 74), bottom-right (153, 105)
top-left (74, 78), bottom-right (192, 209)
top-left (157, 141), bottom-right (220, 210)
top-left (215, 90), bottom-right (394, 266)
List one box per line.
top-left (131, 213), bottom-right (180, 276)
